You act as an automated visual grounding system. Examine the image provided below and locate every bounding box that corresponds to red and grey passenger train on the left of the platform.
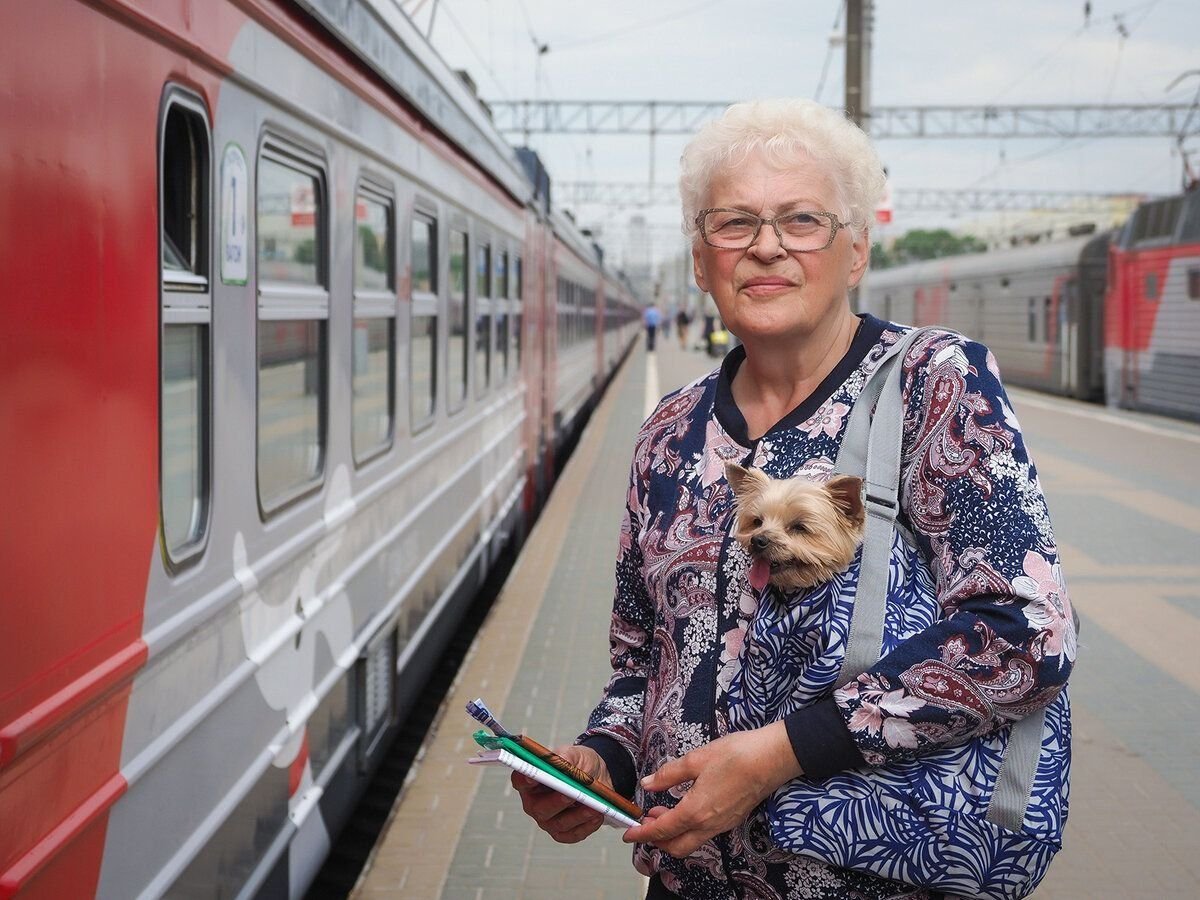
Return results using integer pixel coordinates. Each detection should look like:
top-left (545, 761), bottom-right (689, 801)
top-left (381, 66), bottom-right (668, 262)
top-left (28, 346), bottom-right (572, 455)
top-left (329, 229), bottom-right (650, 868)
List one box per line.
top-left (0, 0), bottom-right (637, 900)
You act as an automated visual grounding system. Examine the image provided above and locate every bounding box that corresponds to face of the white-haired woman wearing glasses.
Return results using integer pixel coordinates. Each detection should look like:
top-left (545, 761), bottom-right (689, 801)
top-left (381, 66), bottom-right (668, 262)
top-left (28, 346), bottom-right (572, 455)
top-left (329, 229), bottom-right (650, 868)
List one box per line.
top-left (692, 155), bottom-right (870, 344)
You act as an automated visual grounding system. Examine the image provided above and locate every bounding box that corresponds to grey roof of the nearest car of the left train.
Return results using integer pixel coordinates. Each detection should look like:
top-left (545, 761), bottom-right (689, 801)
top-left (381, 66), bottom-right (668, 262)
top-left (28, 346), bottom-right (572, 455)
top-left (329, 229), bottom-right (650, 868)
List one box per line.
top-left (295, 0), bottom-right (534, 205)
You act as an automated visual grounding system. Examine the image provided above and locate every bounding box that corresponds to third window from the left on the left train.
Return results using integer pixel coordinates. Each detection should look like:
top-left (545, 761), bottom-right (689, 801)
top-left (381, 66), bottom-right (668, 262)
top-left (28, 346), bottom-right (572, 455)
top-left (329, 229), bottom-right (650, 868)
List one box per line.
top-left (350, 188), bottom-right (396, 462)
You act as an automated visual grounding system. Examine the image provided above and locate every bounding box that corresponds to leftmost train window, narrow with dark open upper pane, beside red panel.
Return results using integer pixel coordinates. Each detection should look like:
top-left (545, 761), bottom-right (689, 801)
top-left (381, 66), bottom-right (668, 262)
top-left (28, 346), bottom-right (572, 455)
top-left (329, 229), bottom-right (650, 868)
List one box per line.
top-left (158, 88), bottom-right (212, 565)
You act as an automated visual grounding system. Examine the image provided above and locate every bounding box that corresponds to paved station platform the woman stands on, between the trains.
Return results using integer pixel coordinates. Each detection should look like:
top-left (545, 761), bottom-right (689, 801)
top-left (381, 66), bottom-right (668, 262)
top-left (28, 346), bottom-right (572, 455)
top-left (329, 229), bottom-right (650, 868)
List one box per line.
top-left (352, 335), bottom-right (1200, 900)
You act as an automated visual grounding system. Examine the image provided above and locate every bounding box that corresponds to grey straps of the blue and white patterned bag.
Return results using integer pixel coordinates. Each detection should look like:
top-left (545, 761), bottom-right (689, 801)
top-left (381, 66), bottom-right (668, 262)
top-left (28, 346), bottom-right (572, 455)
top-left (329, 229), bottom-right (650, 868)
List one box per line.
top-left (834, 328), bottom-right (1045, 832)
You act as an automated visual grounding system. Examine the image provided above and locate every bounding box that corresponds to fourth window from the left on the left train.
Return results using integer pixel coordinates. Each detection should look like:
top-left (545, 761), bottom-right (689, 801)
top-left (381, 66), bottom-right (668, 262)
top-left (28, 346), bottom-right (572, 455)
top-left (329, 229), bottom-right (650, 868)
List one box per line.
top-left (408, 212), bottom-right (438, 431)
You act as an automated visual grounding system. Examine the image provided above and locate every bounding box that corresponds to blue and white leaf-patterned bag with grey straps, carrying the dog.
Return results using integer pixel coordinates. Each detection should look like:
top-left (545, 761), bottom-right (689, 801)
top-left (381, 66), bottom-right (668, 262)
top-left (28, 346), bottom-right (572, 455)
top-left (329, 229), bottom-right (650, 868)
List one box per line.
top-left (732, 331), bottom-right (1070, 900)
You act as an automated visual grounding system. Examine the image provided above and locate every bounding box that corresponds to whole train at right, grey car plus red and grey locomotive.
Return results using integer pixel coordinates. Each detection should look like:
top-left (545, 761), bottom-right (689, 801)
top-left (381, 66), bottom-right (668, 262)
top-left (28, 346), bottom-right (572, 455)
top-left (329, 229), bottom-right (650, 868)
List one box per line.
top-left (863, 190), bottom-right (1200, 420)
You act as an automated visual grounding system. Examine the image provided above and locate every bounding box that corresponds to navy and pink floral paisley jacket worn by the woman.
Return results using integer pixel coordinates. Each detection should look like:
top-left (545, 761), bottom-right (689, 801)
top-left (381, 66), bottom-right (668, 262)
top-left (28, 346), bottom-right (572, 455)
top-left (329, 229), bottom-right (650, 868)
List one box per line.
top-left (581, 316), bottom-right (1075, 900)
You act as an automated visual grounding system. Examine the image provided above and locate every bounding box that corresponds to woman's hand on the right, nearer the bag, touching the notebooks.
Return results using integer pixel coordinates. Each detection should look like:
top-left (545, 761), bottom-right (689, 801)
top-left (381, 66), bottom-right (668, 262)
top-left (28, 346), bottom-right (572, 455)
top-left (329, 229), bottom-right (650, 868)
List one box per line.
top-left (624, 722), bottom-right (803, 857)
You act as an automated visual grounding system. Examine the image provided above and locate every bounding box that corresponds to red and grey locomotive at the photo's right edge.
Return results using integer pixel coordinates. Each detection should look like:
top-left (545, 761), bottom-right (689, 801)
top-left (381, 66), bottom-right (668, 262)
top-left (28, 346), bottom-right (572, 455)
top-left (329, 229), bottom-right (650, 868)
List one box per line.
top-left (1104, 190), bottom-right (1200, 420)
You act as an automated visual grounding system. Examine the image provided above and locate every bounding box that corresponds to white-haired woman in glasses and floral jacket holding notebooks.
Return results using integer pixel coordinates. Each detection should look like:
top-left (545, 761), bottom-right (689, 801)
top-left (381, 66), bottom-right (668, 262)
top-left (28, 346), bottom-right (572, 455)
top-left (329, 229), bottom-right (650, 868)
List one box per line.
top-left (514, 101), bottom-right (1075, 898)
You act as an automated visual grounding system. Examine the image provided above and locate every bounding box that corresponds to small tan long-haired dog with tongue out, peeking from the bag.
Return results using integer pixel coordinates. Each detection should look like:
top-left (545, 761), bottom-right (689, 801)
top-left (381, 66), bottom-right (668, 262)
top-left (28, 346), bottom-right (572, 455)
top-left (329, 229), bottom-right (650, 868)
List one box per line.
top-left (725, 462), bottom-right (866, 590)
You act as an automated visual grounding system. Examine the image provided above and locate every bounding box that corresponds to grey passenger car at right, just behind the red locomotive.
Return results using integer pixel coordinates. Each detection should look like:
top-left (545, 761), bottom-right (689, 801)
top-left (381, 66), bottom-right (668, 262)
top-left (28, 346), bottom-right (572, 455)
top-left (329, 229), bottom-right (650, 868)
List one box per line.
top-left (863, 234), bottom-right (1110, 400)
